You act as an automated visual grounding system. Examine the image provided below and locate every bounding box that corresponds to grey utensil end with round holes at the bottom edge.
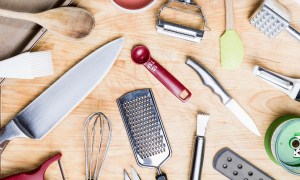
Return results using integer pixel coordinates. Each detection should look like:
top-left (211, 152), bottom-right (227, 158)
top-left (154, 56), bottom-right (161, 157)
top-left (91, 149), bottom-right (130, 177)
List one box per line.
top-left (213, 148), bottom-right (274, 180)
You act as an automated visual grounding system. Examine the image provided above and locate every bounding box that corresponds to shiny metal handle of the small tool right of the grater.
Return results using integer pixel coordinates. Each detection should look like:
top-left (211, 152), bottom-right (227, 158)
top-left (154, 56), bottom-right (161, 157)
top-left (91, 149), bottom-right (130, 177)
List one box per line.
top-left (190, 136), bottom-right (205, 180)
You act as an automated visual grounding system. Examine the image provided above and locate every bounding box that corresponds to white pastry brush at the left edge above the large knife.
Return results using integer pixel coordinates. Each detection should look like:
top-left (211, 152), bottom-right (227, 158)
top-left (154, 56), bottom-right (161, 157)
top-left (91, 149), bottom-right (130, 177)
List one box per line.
top-left (0, 51), bottom-right (54, 79)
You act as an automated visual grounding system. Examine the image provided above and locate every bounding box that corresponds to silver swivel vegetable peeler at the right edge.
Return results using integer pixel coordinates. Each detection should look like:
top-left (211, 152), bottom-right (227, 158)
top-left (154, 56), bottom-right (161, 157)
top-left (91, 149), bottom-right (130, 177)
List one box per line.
top-left (253, 66), bottom-right (300, 101)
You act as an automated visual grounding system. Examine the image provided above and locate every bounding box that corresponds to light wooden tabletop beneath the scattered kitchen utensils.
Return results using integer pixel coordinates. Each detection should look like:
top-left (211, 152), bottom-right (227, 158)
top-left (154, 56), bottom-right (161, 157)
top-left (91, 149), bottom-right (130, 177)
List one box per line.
top-left (1, 0), bottom-right (300, 180)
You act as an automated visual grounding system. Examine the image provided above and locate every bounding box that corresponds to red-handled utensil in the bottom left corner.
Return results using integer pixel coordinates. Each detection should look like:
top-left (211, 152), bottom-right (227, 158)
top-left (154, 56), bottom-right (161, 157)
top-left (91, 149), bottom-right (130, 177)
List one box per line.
top-left (2, 153), bottom-right (66, 180)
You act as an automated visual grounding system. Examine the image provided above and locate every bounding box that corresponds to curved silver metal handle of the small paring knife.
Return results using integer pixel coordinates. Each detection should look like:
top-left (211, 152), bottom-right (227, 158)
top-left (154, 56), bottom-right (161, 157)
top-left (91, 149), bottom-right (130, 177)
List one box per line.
top-left (185, 58), bottom-right (231, 104)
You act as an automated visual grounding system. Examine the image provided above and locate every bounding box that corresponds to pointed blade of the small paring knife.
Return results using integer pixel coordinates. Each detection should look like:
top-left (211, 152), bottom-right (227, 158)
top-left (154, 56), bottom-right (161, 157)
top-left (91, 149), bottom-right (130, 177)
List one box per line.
top-left (226, 99), bottom-right (261, 136)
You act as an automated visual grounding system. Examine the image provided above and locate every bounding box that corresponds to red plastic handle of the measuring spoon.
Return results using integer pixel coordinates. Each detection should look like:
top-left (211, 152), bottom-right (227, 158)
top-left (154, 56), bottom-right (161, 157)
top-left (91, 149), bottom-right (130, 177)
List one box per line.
top-left (144, 57), bottom-right (192, 102)
